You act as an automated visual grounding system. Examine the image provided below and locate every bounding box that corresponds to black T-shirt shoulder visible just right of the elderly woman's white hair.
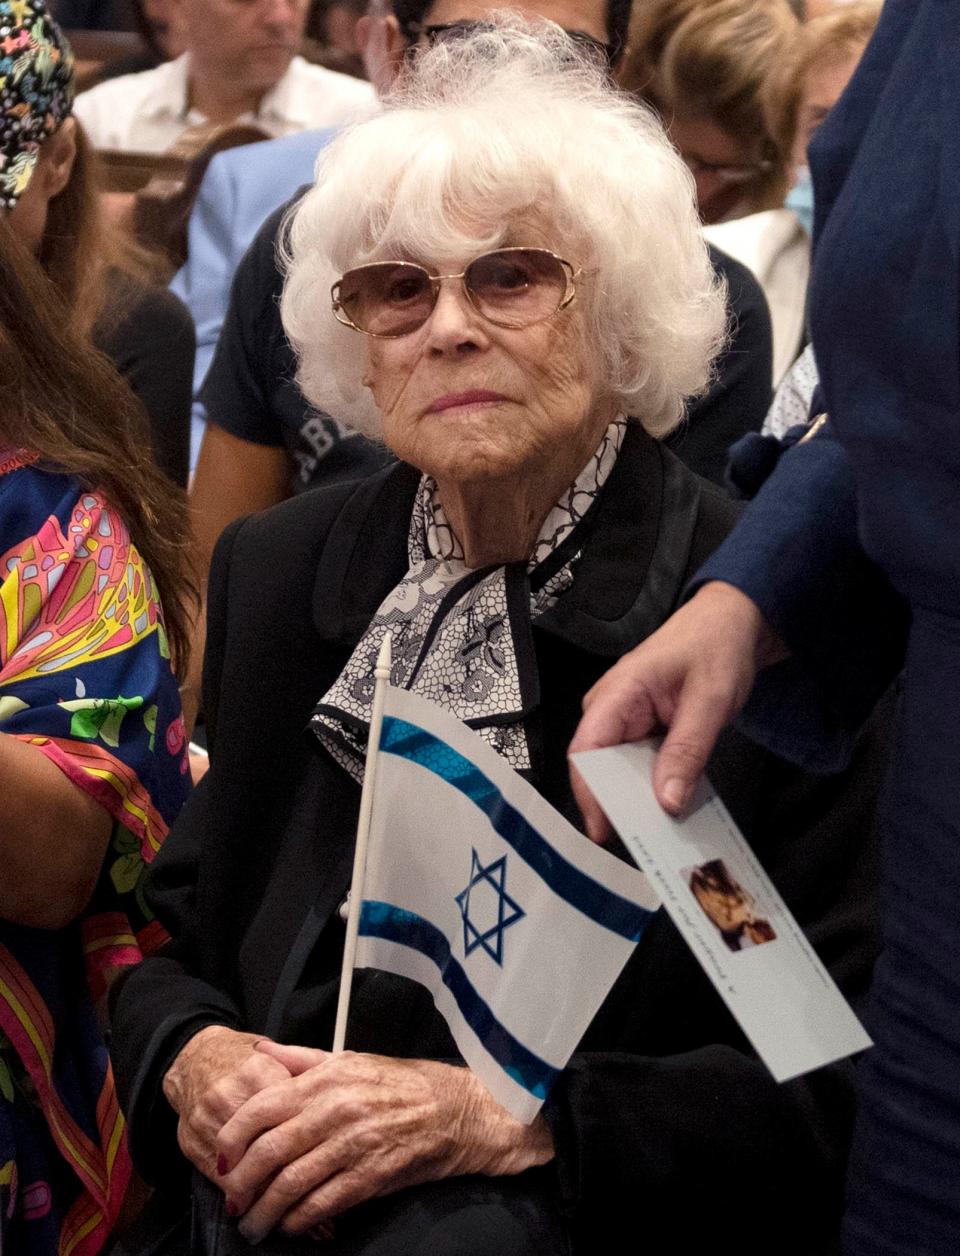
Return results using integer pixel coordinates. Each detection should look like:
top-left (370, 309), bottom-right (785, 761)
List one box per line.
top-left (666, 247), bottom-right (773, 485)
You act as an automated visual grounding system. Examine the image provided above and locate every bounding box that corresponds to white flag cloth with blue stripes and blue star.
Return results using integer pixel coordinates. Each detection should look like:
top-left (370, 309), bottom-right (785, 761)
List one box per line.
top-left (356, 687), bottom-right (658, 1122)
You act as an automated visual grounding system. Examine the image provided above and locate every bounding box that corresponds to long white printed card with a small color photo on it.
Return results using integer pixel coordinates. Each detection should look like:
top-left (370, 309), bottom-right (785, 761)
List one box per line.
top-left (573, 741), bottom-right (871, 1081)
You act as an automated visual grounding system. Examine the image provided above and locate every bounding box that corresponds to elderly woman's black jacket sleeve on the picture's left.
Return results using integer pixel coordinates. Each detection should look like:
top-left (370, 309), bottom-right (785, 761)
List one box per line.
top-left (112, 474), bottom-right (366, 1184)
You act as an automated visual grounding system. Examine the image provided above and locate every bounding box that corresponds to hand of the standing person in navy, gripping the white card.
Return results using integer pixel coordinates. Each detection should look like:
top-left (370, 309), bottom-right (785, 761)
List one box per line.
top-left (570, 582), bottom-right (787, 842)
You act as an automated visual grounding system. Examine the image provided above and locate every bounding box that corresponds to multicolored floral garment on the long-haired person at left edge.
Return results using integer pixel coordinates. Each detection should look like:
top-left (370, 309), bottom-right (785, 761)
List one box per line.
top-left (0, 451), bottom-right (188, 1256)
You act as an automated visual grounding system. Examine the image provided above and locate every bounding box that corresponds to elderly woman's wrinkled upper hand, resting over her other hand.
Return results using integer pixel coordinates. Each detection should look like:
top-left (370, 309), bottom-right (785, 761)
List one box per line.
top-left (217, 1041), bottom-right (554, 1243)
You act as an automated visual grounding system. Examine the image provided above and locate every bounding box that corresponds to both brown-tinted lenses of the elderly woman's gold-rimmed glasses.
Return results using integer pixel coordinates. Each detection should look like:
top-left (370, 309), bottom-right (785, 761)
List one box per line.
top-left (337, 249), bottom-right (569, 337)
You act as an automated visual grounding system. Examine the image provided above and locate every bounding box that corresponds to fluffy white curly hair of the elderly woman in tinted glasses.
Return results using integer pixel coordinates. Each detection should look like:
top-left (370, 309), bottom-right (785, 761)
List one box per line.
top-left (281, 14), bottom-right (725, 440)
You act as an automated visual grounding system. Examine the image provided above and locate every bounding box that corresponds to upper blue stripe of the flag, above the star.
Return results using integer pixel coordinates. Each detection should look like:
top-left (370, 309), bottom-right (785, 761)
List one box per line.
top-left (379, 716), bottom-right (653, 942)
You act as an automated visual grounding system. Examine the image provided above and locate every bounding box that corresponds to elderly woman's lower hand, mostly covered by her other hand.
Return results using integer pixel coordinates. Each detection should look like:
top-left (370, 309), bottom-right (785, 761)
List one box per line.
top-left (163, 1025), bottom-right (290, 1186)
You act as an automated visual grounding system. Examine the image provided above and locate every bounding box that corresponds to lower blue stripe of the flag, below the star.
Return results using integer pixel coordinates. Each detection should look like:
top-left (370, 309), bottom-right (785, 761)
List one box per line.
top-left (359, 904), bottom-right (560, 1099)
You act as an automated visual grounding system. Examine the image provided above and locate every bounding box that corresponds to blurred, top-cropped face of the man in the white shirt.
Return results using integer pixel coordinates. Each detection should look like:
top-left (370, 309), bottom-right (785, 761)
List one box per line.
top-left (178, 0), bottom-right (308, 92)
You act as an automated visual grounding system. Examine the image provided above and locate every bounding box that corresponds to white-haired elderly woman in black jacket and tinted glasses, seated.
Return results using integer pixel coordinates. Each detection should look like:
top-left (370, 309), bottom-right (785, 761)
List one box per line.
top-left (114, 23), bottom-right (872, 1253)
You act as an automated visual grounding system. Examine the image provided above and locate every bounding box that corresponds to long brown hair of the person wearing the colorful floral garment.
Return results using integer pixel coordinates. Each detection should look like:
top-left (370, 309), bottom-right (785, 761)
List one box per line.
top-left (0, 223), bottom-right (196, 674)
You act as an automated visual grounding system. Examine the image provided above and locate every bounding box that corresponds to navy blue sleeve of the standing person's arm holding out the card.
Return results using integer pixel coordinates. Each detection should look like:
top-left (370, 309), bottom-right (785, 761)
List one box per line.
top-left (691, 425), bottom-right (908, 771)
